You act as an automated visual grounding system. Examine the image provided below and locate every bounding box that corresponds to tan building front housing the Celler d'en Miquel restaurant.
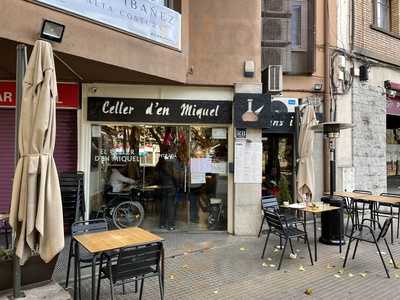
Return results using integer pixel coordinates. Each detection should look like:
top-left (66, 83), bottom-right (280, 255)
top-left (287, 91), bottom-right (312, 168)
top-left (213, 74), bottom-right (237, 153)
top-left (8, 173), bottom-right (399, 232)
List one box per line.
top-left (0, 0), bottom-right (267, 234)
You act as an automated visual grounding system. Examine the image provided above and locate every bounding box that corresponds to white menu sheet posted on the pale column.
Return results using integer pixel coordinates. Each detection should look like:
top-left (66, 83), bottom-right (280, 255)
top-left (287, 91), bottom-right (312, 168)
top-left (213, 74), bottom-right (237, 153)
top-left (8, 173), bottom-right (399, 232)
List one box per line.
top-left (234, 141), bottom-right (262, 183)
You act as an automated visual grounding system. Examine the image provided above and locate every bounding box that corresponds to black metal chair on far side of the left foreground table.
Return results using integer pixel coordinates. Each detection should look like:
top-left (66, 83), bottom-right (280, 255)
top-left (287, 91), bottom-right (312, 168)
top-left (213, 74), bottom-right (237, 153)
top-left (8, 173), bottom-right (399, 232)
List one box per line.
top-left (65, 219), bottom-right (108, 295)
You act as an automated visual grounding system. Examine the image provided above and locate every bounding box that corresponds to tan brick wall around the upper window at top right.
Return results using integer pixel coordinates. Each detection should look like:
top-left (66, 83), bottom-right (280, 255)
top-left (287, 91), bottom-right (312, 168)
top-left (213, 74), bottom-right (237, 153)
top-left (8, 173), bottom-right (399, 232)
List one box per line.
top-left (354, 0), bottom-right (400, 65)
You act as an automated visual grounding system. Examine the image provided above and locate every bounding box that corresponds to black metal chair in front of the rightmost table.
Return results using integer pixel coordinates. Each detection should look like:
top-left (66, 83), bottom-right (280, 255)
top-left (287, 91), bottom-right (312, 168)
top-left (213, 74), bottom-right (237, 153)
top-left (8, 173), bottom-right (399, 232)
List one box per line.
top-left (343, 217), bottom-right (397, 278)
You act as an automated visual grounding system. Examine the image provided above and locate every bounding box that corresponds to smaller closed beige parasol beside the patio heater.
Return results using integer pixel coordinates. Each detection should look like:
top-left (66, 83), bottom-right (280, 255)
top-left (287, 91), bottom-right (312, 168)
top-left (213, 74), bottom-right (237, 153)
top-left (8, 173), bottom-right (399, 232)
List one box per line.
top-left (297, 105), bottom-right (318, 200)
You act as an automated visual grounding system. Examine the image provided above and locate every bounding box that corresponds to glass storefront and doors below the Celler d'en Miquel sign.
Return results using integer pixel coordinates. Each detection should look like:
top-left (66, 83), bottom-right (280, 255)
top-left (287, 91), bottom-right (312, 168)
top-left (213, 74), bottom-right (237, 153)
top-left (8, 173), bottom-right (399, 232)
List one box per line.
top-left (90, 125), bottom-right (228, 230)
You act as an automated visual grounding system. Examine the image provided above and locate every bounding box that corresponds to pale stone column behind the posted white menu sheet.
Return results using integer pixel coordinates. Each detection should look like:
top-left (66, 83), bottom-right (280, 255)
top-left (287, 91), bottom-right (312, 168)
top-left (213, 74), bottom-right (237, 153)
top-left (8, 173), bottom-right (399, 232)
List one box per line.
top-left (234, 83), bottom-right (262, 235)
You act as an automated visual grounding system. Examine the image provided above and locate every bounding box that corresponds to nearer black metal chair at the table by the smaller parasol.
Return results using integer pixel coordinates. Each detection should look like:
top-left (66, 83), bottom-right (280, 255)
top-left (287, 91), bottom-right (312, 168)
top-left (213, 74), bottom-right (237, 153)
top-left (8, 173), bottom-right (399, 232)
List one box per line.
top-left (261, 210), bottom-right (314, 270)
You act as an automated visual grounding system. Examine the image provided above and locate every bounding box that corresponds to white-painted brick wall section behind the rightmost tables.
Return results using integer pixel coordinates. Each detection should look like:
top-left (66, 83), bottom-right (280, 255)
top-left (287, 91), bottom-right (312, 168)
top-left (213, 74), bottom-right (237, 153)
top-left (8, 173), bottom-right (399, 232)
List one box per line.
top-left (353, 80), bottom-right (386, 194)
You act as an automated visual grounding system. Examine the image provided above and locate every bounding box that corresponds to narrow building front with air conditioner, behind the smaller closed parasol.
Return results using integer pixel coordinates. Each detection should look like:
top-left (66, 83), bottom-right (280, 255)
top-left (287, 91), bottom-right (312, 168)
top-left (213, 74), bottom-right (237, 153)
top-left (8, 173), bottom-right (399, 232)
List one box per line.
top-left (261, 0), bottom-right (336, 201)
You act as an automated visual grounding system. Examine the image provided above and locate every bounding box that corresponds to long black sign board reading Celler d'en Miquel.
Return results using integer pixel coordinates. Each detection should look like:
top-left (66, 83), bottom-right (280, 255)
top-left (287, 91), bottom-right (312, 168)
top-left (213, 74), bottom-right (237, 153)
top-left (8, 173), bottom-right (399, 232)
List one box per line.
top-left (87, 97), bottom-right (232, 124)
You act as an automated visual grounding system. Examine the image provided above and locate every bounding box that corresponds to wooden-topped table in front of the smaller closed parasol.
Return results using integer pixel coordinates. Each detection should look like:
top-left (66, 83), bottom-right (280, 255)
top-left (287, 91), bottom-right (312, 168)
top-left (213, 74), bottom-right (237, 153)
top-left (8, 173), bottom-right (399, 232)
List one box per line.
top-left (281, 203), bottom-right (343, 261)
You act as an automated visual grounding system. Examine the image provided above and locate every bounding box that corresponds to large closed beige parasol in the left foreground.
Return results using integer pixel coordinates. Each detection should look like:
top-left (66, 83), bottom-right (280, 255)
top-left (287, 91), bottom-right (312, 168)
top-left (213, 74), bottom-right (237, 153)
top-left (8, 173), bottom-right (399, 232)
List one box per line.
top-left (10, 41), bottom-right (64, 265)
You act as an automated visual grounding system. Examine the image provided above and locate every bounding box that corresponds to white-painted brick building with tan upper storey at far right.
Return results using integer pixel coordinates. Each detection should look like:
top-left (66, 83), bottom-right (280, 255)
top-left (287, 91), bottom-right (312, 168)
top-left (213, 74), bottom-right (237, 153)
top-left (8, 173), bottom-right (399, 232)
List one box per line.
top-left (333, 0), bottom-right (400, 193)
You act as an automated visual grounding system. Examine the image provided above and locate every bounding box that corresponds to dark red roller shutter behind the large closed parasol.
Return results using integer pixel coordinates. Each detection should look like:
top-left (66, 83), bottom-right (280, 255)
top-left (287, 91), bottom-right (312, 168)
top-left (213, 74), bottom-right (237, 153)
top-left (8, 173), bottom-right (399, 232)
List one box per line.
top-left (0, 109), bottom-right (77, 212)
